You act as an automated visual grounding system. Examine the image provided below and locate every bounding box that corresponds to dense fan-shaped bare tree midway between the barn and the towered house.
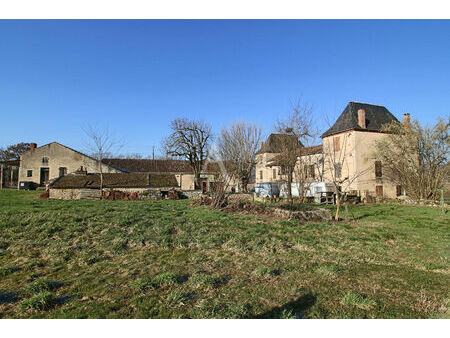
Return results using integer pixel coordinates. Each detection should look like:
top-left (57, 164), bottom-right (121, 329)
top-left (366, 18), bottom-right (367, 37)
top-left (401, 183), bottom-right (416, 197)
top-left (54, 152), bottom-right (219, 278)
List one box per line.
top-left (217, 122), bottom-right (262, 192)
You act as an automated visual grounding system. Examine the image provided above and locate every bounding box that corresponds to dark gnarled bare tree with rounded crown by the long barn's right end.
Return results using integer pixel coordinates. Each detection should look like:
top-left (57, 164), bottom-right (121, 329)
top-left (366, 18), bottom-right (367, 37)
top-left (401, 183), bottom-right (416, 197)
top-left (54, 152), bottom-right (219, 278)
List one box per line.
top-left (163, 118), bottom-right (213, 188)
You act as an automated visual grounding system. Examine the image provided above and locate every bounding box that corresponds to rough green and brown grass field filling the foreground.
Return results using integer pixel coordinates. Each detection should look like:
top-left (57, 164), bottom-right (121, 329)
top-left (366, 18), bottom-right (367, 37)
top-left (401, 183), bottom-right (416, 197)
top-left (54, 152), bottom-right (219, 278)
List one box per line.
top-left (0, 191), bottom-right (450, 318)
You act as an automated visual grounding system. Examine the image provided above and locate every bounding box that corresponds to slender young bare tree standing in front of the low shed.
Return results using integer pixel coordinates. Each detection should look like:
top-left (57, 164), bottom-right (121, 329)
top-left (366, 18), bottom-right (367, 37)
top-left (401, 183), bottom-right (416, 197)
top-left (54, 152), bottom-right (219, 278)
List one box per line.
top-left (83, 126), bottom-right (122, 196)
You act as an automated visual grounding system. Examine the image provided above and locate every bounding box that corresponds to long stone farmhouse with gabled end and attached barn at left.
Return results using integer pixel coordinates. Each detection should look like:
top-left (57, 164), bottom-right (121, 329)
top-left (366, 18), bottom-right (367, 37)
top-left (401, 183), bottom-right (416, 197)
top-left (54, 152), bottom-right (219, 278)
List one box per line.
top-left (18, 142), bottom-right (234, 193)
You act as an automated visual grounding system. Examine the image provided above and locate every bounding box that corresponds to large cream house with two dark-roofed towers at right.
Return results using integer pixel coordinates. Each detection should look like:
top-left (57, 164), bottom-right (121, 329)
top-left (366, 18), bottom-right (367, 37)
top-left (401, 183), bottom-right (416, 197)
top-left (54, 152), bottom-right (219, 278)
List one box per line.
top-left (256, 102), bottom-right (410, 199)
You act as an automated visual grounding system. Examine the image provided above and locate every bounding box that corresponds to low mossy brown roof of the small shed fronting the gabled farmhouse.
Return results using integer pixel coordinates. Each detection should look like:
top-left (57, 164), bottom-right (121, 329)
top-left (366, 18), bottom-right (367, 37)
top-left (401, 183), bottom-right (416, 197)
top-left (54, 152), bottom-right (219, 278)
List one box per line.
top-left (51, 173), bottom-right (178, 189)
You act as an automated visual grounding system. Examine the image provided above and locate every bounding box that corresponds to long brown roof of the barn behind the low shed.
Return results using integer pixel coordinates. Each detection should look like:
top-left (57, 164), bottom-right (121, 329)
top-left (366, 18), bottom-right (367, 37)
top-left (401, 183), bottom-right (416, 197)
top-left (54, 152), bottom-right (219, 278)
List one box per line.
top-left (103, 158), bottom-right (219, 174)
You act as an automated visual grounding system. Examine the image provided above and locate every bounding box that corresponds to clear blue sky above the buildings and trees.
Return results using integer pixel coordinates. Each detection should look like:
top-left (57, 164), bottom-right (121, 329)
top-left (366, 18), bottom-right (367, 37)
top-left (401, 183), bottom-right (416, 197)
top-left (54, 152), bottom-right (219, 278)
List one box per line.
top-left (0, 20), bottom-right (450, 156)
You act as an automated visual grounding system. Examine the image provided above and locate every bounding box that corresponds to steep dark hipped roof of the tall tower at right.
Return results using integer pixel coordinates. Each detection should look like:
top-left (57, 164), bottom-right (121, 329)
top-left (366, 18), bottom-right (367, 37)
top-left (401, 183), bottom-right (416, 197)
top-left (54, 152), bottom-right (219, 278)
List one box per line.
top-left (322, 102), bottom-right (398, 137)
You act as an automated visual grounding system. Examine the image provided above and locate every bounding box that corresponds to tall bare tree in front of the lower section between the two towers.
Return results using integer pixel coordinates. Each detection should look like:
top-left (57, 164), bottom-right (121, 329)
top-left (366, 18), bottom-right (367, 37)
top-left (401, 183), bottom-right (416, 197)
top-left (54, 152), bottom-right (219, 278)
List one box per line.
top-left (268, 100), bottom-right (314, 203)
